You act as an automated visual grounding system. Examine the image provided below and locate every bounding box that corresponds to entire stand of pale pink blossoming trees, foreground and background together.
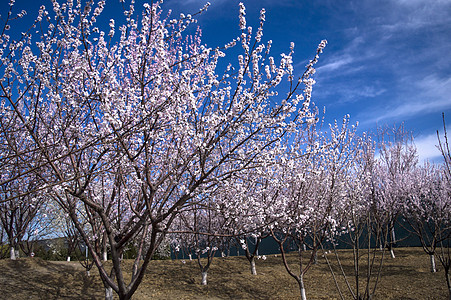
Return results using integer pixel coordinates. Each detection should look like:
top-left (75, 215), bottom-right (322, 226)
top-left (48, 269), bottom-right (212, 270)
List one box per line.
top-left (0, 0), bottom-right (450, 299)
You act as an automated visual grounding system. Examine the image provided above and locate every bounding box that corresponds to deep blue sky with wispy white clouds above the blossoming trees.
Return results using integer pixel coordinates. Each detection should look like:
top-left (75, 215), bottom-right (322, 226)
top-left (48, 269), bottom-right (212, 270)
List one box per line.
top-left (0, 0), bottom-right (451, 160)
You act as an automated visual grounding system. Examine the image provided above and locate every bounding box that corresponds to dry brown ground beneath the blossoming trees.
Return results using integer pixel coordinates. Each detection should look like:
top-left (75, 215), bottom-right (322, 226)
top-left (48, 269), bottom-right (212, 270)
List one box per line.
top-left (0, 248), bottom-right (448, 300)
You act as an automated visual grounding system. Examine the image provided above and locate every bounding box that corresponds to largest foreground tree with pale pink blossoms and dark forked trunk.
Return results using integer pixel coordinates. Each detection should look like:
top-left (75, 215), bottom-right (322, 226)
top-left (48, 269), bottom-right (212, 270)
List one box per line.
top-left (0, 0), bottom-right (326, 299)
